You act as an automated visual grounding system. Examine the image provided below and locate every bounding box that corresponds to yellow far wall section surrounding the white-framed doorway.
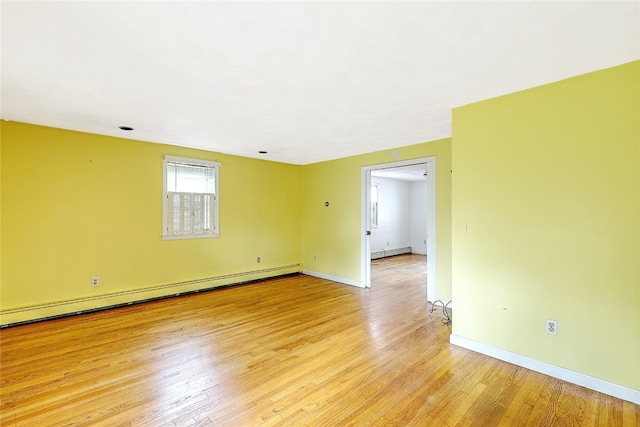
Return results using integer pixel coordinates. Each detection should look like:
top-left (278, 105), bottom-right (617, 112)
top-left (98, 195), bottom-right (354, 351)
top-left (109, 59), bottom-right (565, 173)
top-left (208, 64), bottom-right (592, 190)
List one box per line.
top-left (302, 138), bottom-right (451, 300)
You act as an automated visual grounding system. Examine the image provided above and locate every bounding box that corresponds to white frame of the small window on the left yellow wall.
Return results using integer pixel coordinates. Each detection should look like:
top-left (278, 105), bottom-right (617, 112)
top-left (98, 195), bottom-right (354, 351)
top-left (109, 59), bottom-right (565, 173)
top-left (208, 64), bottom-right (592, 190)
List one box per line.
top-left (162, 155), bottom-right (222, 240)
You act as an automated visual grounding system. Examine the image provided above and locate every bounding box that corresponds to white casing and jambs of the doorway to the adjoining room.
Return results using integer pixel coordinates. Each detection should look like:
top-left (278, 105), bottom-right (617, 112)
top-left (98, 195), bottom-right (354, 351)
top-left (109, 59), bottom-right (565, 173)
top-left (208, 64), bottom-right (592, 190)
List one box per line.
top-left (361, 156), bottom-right (437, 302)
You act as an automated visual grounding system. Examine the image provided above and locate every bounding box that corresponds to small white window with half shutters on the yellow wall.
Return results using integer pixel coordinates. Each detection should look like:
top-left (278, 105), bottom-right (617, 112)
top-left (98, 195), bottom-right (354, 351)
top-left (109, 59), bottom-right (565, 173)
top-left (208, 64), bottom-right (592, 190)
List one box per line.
top-left (162, 156), bottom-right (221, 239)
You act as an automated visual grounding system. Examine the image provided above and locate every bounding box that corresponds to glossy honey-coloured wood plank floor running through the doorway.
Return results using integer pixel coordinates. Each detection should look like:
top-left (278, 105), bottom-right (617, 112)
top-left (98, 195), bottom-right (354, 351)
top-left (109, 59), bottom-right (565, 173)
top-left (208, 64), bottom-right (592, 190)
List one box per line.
top-left (0, 255), bottom-right (640, 427)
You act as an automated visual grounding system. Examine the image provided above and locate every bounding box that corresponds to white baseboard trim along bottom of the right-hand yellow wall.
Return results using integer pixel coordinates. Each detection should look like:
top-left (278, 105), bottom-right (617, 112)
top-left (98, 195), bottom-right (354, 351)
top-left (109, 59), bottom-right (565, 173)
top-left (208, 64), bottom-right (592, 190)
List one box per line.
top-left (449, 334), bottom-right (640, 405)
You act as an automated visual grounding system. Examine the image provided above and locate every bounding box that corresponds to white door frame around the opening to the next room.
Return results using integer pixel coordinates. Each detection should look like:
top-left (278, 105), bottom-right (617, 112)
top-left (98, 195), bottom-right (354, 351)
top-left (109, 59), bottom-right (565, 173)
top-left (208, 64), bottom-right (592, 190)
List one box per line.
top-left (360, 156), bottom-right (437, 302)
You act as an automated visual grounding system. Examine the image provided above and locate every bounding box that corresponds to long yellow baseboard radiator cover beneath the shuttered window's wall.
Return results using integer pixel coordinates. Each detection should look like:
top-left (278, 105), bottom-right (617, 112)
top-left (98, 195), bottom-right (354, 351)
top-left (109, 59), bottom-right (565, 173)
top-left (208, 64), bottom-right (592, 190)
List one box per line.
top-left (0, 264), bottom-right (302, 328)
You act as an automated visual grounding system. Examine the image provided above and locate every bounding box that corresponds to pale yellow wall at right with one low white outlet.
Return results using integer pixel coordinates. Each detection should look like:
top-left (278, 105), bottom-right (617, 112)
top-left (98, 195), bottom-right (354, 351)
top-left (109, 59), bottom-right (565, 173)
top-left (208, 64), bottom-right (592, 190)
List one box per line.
top-left (452, 61), bottom-right (640, 389)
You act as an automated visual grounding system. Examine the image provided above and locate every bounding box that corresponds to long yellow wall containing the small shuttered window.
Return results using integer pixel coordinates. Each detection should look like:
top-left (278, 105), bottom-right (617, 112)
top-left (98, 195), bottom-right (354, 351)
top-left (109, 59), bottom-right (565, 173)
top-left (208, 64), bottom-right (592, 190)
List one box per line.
top-left (0, 122), bottom-right (302, 324)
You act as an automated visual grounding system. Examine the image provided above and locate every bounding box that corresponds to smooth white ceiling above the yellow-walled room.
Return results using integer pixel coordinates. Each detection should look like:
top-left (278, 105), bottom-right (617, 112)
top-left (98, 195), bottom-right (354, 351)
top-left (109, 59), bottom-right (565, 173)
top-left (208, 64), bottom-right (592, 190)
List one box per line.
top-left (0, 1), bottom-right (640, 164)
